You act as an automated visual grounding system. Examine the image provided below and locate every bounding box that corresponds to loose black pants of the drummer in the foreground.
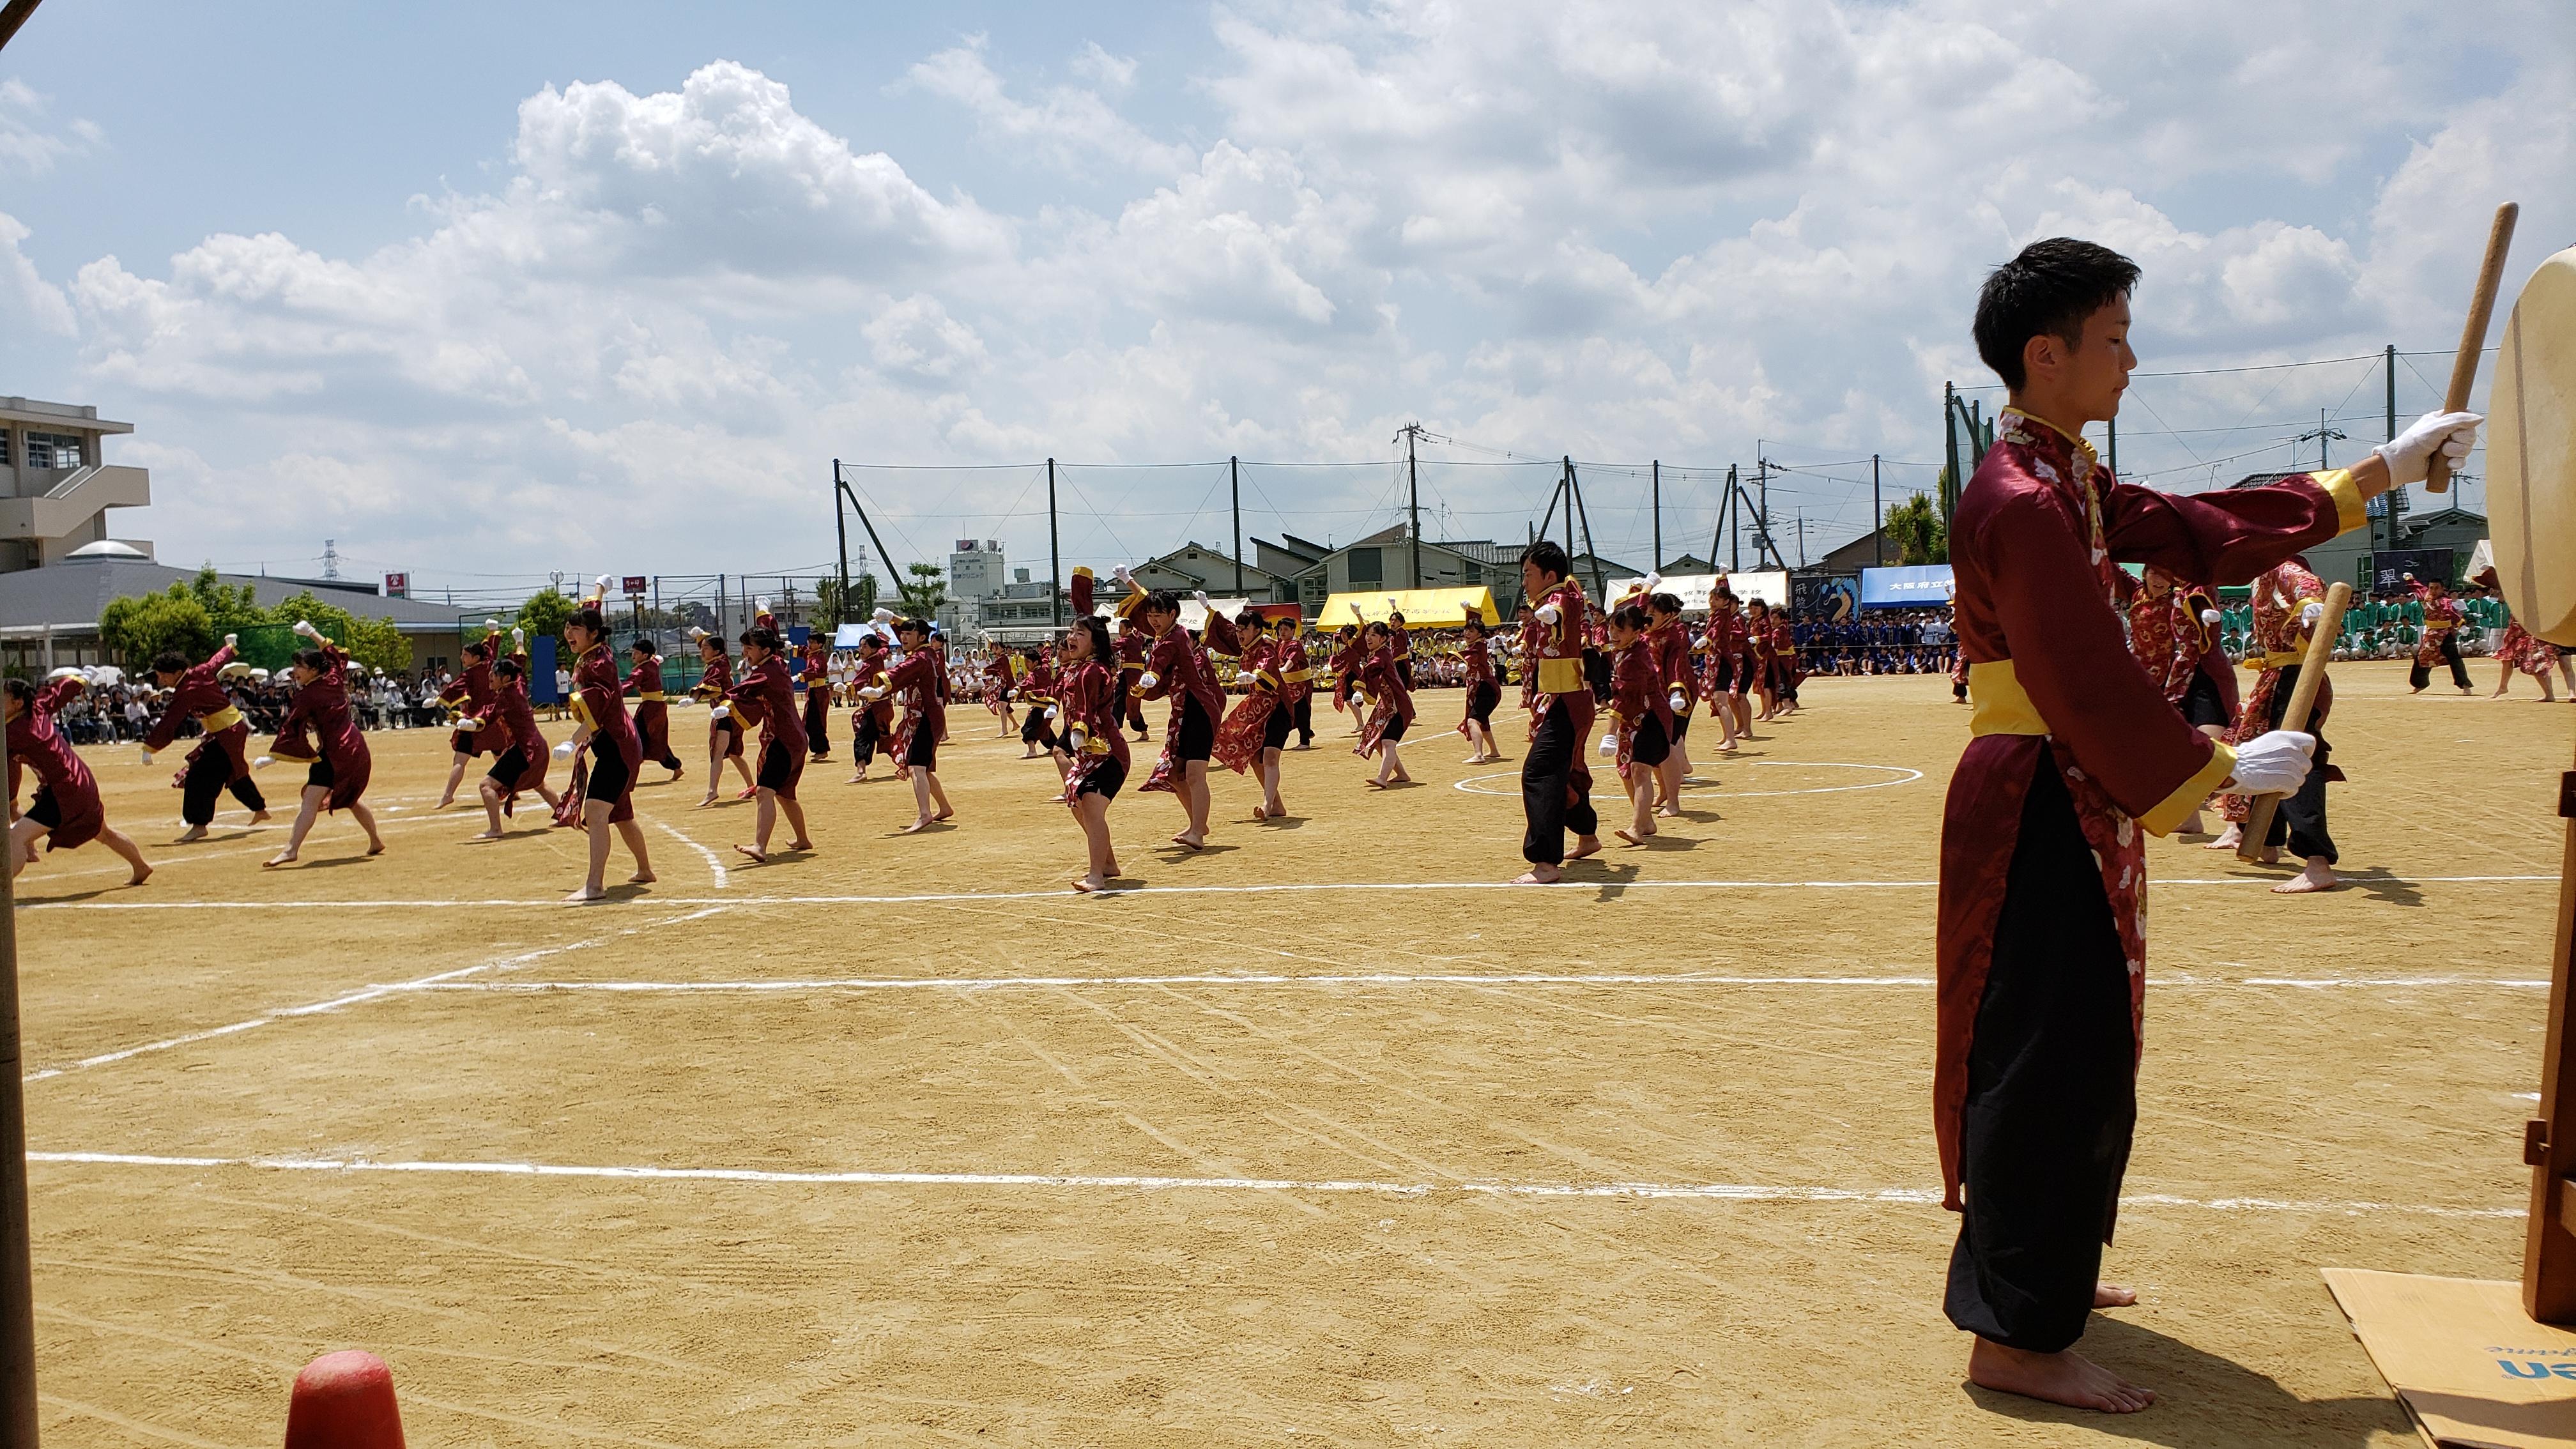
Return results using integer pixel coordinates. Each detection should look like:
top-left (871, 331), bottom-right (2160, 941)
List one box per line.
top-left (1942, 750), bottom-right (2138, 1354)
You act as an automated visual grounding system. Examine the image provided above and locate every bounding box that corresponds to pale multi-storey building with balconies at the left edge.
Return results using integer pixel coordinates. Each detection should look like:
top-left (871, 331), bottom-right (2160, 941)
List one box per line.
top-left (0, 397), bottom-right (152, 572)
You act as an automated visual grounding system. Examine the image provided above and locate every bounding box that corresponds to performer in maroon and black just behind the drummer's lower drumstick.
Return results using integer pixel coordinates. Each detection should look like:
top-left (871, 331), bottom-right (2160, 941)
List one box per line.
top-left (2195, 557), bottom-right (2344, 894)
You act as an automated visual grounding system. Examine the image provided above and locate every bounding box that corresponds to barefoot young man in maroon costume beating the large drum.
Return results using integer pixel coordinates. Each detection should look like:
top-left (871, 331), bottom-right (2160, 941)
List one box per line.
top-left (1932, 237), bottom-right (2478, 1413)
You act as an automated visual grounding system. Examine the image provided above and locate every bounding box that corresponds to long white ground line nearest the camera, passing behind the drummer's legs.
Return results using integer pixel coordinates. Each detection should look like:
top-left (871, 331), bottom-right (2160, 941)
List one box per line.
top-left (26, 1153), bottom-right (2524, 1217)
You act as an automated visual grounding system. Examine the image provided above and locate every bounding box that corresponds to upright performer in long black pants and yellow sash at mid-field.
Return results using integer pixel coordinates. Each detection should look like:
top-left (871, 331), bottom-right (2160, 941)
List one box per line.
top-left (1515, 539), bottom-right (1602, 884)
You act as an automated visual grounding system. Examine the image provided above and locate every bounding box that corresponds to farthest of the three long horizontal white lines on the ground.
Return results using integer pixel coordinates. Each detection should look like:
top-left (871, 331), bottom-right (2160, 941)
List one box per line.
top-left (18, 877), bottom-right (2558, 910)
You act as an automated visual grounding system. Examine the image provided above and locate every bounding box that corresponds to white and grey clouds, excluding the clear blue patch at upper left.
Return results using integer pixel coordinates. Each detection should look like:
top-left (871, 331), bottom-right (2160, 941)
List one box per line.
top-left (0, 0), bottom-right (2576, 588)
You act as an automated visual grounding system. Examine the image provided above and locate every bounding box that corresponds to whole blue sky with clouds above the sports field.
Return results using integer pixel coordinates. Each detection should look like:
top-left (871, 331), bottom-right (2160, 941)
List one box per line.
top-left (0, 0), bottom-right (2576, 593)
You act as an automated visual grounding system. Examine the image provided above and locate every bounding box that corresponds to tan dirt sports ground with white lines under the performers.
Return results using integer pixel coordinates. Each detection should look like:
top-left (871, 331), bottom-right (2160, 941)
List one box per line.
top-left (18, 663), bottom-right (2576, 1446)
